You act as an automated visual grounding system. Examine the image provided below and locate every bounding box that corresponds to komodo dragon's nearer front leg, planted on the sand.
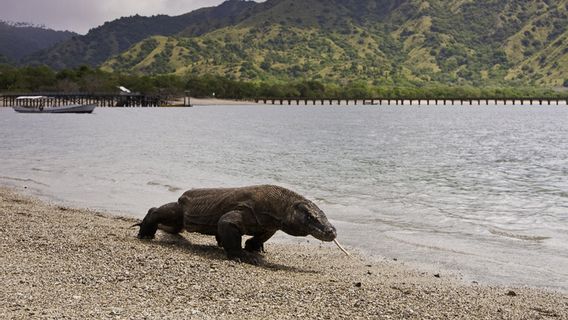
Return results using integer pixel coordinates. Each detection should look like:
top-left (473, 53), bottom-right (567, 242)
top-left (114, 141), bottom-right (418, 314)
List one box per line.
top-left (217, 210), bottom-right (262, 264)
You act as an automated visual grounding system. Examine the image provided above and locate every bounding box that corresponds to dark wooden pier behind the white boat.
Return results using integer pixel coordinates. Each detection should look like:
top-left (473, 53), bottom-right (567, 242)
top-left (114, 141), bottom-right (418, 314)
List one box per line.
top-left (0, 93), bottom-right (172, 107)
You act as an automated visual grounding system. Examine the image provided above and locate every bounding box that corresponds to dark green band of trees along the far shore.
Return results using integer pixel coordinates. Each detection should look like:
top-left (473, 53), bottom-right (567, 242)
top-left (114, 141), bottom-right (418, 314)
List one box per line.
top-left (0, 65), bottom-right (568, 99)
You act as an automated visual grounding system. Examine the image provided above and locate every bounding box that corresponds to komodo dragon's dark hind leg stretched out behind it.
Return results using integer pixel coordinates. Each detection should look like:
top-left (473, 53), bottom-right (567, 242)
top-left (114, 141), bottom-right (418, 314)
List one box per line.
top-left (137, 202), bottom-right (183, 239)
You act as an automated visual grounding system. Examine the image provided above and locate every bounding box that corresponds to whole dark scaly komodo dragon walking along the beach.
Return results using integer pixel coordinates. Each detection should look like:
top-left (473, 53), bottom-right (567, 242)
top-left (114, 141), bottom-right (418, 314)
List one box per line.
top-left (138, 185), bottom-right (337, 264)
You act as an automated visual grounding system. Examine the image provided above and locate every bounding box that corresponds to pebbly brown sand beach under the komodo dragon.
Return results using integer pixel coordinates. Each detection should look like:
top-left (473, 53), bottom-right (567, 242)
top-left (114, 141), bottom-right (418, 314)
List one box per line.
top-left (0, 188), bottom-right (568, 319)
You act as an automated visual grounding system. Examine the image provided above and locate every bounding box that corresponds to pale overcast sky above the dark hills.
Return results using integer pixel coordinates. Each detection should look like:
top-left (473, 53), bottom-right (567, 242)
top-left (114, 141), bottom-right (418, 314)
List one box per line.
top-left (0, 0), bottom-right (234, 34)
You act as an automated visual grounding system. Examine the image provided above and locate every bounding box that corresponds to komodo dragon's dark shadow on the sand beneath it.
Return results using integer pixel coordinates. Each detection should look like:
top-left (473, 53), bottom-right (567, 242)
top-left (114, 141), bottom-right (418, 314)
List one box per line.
top-left (141, 233), bottom-right (319, 274)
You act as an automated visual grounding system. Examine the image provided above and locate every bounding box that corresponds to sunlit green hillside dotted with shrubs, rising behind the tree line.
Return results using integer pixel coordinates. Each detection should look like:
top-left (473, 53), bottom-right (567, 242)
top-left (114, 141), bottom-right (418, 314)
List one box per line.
top-left (30, 0), bottom-right (568, 87)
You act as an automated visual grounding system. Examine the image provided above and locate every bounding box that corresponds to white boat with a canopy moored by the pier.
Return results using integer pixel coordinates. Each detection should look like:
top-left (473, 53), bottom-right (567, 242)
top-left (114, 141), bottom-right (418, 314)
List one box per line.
top-left (12, 96), bottom-right (97, 113)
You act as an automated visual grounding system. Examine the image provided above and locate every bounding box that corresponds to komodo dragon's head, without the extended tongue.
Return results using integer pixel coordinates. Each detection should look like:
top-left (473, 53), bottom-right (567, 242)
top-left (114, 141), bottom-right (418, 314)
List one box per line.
top-left (282, 200), bottom-right (337, 241)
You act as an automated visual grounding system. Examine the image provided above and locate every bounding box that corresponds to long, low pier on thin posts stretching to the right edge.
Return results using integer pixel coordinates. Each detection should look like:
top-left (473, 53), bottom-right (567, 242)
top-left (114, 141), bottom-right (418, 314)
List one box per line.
top-left (255, 98), bottom-right (568, 106)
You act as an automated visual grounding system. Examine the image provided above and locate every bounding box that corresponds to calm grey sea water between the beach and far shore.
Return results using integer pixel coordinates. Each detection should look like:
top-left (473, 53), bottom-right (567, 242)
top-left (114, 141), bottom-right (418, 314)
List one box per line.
top-left (0, 106), bottom-right (568, 291)
